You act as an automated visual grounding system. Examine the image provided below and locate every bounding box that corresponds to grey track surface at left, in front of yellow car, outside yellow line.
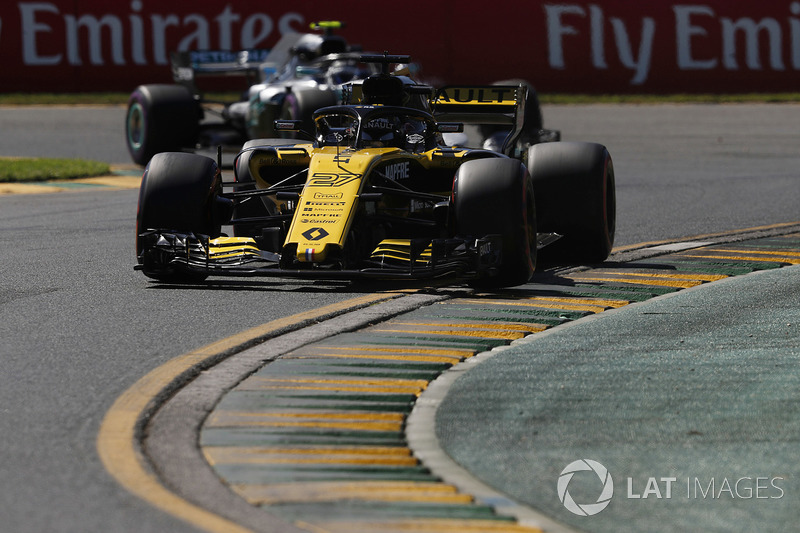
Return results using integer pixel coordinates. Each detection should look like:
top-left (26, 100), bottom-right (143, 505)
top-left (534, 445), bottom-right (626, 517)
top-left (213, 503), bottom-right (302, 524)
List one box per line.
top-left (0, 190), bottom-right (363, 533)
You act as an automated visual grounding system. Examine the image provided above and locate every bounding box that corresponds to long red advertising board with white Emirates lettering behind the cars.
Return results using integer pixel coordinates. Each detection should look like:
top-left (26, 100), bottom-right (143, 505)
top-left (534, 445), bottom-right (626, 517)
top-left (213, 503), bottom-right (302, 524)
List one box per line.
top-left (0, 0), bottom-right (800, 93)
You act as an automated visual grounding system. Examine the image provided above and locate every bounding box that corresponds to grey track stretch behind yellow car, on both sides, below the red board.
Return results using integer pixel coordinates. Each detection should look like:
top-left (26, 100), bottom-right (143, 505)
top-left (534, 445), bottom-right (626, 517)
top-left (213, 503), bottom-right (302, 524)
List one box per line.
top-left (0, 104), bottom-right (800, 245)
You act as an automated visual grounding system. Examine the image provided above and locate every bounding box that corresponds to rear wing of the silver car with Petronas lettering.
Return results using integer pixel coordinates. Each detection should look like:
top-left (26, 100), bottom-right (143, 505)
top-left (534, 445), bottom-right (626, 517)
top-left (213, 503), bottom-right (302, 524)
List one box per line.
top-left (170, 49), bottom-right (269, 94)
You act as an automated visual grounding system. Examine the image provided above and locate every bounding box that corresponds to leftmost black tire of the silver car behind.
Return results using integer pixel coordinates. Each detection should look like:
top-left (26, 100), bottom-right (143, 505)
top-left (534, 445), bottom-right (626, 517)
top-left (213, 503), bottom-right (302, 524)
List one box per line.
top-left (125, 85), bottom-right (202, 165)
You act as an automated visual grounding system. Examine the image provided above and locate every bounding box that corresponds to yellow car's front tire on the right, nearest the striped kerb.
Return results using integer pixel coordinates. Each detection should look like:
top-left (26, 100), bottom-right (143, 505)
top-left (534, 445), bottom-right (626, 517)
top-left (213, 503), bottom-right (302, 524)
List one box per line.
top-left (453, 158), bottom-right (537, 287)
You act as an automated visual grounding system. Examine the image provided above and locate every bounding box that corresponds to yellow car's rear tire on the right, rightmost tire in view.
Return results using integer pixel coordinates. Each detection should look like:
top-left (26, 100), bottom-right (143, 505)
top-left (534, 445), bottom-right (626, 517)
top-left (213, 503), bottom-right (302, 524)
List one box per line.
top-left (528, 142), bottom-right (616, 264)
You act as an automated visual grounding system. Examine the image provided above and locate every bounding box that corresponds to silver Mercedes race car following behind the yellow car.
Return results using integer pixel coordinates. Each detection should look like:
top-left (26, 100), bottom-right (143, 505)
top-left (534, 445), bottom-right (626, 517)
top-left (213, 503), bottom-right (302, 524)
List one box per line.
top-left (125, 21), bottom-right (384, 165)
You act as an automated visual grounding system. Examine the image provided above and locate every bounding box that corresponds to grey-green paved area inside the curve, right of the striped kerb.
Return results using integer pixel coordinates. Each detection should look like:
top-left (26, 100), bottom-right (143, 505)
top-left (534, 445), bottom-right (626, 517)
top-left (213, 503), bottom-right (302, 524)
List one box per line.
top-left (436, 266), bottom-right (800, 532)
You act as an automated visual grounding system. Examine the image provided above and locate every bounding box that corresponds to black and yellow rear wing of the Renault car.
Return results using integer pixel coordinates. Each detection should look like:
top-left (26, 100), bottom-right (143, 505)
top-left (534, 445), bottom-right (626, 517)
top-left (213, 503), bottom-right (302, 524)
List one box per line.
top-left (431, 84), bottom-right (528, 154)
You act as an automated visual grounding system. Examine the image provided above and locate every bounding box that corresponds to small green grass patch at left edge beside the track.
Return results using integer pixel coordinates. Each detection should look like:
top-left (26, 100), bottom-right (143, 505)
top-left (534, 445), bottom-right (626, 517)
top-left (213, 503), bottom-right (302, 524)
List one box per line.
top-left (0, 158), bottom-right (111, 183)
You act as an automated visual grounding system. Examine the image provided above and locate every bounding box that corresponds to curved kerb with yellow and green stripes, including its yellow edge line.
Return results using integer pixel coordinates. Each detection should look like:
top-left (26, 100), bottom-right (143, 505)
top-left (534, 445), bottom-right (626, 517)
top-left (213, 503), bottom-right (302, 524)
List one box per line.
top-left (98, 222), bottom-right (800, 533)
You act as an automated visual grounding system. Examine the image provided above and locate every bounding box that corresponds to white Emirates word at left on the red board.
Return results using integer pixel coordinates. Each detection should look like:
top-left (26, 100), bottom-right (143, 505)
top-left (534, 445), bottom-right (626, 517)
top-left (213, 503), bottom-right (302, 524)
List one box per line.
top-left (17, 0), bottom-right (305, 66)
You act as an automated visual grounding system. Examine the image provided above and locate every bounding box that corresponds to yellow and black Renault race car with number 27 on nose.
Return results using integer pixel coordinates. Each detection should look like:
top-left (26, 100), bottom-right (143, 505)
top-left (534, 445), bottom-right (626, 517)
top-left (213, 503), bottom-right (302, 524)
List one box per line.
top-left (136, 55), bottom-right (615, 287)
